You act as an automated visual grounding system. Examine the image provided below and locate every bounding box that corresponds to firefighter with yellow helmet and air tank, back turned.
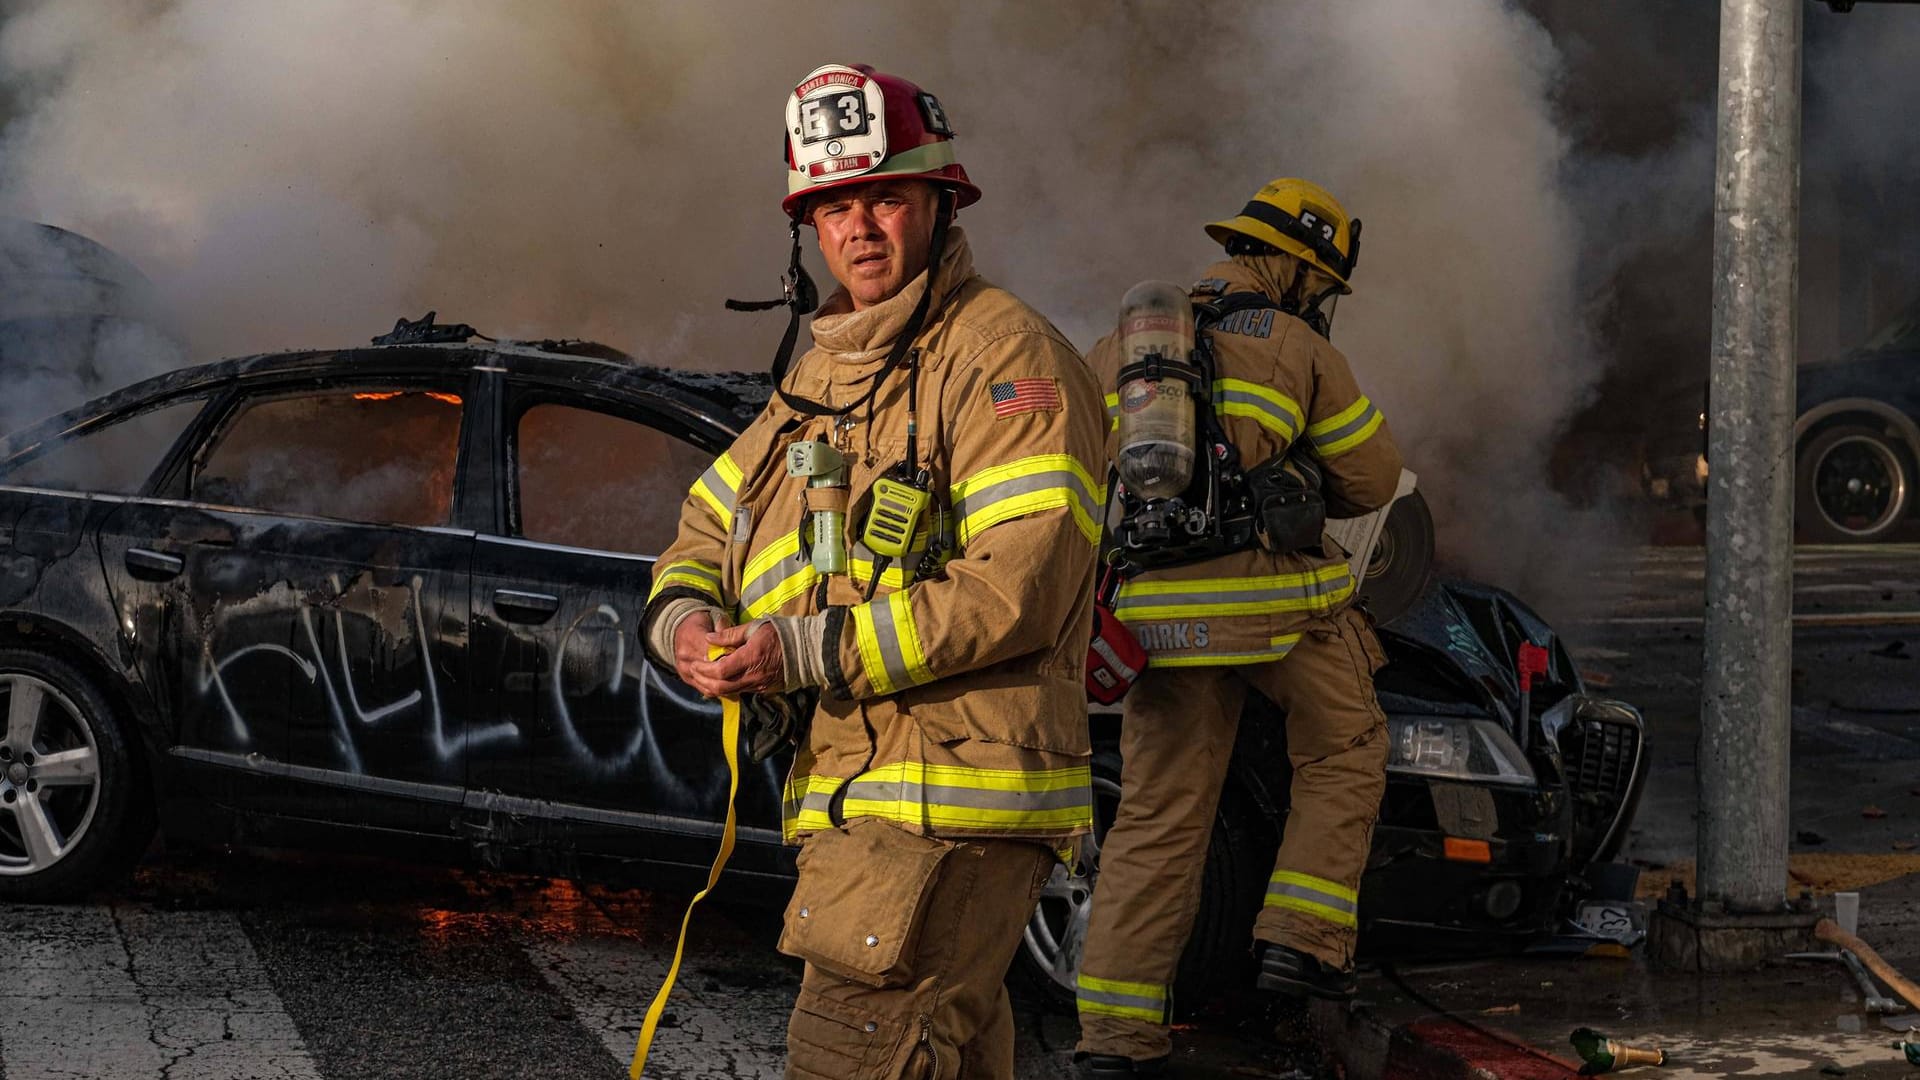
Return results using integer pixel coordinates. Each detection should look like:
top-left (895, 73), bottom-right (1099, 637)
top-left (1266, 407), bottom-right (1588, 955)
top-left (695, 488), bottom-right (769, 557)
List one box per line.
top-left (1077, 179), bottom-right (1400, 1078)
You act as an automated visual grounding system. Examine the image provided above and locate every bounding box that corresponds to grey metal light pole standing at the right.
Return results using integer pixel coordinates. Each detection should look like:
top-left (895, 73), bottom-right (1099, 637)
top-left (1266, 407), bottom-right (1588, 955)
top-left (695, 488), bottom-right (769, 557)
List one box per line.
top-left (1699, 0), bottom-right (1805, 913)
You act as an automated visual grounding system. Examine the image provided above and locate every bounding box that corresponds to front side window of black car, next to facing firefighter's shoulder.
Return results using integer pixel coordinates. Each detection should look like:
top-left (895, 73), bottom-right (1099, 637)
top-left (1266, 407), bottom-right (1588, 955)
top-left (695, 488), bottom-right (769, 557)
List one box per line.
top-left (515, 404), bottom-right (712, 555)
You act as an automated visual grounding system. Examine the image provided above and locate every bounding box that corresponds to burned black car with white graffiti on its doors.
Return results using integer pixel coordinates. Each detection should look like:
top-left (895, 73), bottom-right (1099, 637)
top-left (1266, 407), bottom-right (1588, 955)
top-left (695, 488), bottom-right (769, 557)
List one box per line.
top-left (0, 330), bottom-right (1644, 994)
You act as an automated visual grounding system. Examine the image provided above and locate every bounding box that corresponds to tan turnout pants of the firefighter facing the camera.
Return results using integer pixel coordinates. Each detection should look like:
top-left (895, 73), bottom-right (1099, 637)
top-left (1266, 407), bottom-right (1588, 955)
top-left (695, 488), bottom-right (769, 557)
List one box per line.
top-left (781, 819), bottom-right (1056, 1080)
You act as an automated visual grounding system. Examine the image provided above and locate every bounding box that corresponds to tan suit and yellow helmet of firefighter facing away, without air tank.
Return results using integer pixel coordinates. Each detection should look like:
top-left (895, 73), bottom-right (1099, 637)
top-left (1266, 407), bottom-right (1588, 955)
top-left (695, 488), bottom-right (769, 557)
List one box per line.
top-left (1077, 179), bottom-right (1400, 1076)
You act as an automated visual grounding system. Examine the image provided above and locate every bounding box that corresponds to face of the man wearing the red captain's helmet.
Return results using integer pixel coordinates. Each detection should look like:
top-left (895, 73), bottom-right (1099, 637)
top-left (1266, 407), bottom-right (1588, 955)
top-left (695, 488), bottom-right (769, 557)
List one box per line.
top-left (814, 181), bottom-right (939, 309)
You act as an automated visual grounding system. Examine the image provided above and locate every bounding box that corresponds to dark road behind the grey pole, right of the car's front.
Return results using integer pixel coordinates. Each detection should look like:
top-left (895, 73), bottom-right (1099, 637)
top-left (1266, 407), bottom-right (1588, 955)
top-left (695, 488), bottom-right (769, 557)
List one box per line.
top-left (1561, 544), bottom-right (1920, 867)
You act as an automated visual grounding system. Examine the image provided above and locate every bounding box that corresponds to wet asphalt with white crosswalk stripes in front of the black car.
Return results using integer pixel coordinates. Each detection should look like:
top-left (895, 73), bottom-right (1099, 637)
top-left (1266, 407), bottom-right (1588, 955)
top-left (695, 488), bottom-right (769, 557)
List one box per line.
top-left (0, 853), bottom-right (1315, 1080)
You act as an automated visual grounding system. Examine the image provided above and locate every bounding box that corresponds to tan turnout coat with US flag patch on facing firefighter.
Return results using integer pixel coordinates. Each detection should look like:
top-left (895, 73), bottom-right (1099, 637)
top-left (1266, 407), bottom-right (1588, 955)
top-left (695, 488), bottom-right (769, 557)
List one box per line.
top-left (649, 229), bottom-right (1106, 849)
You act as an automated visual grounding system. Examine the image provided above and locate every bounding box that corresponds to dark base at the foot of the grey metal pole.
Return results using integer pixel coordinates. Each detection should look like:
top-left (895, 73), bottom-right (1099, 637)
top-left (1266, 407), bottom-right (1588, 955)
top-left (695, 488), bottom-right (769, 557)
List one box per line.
top-left (1647, 886), bottom-right (1820, 974)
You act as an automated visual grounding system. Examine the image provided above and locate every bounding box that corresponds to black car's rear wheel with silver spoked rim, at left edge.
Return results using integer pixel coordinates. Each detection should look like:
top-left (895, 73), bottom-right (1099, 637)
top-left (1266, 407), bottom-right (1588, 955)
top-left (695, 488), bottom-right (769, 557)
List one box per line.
top-left (0, 650), bottom-right (154, 901)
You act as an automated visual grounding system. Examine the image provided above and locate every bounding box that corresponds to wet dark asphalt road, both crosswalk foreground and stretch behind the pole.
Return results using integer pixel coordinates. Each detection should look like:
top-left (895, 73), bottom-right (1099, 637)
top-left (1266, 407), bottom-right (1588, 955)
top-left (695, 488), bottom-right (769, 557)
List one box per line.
top-left (0, 548), bottom-right (1920, 1080)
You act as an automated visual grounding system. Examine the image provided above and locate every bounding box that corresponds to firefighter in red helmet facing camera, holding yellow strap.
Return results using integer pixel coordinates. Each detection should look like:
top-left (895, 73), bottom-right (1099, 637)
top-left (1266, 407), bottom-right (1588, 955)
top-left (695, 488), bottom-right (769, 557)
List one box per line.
top-left (645, 65), bottom-right (1106, 1080)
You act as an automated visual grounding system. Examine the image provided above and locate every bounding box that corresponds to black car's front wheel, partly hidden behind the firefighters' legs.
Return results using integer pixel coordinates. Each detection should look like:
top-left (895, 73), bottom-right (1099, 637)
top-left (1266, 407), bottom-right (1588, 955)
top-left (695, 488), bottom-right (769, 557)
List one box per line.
top-left (1010, 744), bottom-right (1275, 1017)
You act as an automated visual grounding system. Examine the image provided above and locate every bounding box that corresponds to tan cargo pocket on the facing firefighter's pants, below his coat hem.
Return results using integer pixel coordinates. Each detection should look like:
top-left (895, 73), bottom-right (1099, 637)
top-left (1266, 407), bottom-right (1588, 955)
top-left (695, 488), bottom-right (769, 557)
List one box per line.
top-left (780, 817), bottom-right (952, 990)
